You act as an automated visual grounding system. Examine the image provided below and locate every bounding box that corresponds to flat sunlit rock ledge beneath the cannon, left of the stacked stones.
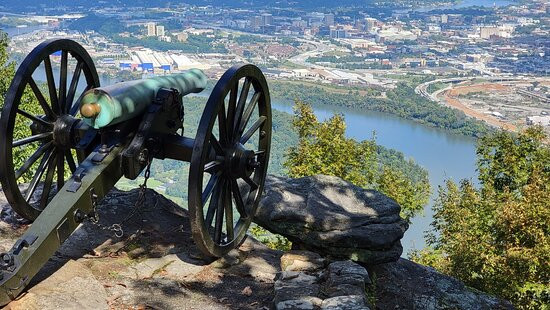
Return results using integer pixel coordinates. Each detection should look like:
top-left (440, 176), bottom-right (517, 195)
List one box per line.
top-left (0, 189), bottom-right (282, 310)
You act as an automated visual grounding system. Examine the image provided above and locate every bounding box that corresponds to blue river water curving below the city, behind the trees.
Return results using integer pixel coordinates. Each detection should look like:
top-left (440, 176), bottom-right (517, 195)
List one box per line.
top-left (272, 100), bottom-right (477, 256)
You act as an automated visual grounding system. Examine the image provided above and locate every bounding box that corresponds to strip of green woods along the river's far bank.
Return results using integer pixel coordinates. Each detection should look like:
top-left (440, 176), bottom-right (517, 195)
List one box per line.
top-left (270, 81), bottom-right (490, 137)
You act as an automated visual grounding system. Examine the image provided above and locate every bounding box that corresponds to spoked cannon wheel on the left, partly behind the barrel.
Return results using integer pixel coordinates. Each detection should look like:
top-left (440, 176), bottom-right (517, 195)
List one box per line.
top-left (0, 39), bottom-right (99, 221)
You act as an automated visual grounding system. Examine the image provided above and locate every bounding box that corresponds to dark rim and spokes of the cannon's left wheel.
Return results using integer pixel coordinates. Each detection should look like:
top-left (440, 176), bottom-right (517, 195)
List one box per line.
top-left (0, 39), bottom-right (99, 221)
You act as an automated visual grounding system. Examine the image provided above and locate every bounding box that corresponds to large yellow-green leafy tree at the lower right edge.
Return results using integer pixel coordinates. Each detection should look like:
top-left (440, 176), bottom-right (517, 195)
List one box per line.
top-left (410, 127), bottom-right (550, 309)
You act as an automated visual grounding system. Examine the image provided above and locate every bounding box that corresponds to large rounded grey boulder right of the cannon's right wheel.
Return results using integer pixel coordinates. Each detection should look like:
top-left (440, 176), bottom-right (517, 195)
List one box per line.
top-left (254, 175), bottom-right (408, 265)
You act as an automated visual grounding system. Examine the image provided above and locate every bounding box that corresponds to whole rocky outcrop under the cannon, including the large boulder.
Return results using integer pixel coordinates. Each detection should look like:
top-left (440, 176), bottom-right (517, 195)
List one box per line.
top-left (0, 177), bottom-right (512, 310)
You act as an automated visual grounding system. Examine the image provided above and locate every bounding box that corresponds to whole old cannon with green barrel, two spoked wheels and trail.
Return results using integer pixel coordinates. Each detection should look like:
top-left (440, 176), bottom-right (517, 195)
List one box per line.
top-left (0, 39), bottom-right (271, 306)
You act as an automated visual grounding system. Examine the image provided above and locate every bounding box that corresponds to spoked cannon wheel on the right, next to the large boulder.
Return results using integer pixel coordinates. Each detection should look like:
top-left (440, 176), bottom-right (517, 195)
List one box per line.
top-left (188, 64), bottom-right (271, 257)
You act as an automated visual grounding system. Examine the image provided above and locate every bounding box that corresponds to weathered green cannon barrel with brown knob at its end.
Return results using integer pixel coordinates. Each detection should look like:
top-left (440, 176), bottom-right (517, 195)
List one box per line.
top-left (80, 69), bottom-right (208, 129)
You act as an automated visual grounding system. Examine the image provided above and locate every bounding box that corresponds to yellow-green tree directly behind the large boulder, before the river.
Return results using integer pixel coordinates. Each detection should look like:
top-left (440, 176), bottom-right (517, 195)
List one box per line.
top-left (284, 101), bottom-right (430, 220)
